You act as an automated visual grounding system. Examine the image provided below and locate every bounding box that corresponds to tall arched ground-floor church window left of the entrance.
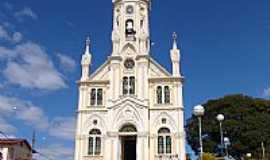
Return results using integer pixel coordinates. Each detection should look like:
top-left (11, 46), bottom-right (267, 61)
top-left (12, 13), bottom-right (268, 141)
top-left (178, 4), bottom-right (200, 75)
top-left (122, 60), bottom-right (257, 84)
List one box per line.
top-left (88, 129), bottom-right (101, 156)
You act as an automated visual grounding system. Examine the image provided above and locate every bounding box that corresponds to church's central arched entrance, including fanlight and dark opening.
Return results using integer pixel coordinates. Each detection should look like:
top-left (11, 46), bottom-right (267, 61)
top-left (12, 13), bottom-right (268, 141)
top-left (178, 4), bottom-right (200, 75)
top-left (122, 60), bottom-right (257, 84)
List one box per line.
top-left (119, 124), bottom-right (137, 160)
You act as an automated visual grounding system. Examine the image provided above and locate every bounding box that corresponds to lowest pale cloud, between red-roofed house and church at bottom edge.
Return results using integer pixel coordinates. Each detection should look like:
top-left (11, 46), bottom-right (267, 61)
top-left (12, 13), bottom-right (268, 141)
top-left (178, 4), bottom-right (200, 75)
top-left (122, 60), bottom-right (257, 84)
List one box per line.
top-left (34, 144), bottom-right (74, 160)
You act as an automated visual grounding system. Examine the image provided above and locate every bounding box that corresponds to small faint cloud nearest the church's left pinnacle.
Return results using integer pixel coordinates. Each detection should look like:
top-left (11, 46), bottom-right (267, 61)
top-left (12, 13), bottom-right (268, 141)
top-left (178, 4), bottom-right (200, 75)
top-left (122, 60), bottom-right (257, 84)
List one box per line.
top-left (57, 53), bottom-right (76, 71)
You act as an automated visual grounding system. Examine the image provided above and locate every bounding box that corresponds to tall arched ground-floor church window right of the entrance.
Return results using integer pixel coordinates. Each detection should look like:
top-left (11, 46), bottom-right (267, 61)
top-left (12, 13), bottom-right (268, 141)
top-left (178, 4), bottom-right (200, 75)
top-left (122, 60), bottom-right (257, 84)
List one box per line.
top-left (158, 128), bottom-right (172, 154)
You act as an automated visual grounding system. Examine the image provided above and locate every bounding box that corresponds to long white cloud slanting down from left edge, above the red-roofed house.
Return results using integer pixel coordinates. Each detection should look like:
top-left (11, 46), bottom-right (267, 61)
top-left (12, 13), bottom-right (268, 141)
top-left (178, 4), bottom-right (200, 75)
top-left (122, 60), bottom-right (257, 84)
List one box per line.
top-left (0, 95), bottom-right (49, 131)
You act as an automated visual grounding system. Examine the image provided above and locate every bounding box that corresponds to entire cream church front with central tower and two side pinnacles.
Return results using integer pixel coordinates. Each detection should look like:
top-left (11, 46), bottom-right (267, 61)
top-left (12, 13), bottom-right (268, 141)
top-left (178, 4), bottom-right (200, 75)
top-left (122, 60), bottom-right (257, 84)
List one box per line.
top-left (74, 0), bottom-right (186, 160)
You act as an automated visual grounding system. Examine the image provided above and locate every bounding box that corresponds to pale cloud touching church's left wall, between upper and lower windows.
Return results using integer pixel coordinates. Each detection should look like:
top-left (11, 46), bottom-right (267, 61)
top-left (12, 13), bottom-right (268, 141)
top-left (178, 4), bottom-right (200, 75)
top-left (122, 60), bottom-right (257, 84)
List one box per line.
top-left (49, 117), bottom-right (76, 140)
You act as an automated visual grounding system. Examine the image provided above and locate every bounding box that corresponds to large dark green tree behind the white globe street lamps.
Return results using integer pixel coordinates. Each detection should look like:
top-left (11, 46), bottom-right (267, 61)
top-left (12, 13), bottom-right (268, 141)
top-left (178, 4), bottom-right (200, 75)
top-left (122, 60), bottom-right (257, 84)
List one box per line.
top-left (186, 94), bottom-right (270, 159)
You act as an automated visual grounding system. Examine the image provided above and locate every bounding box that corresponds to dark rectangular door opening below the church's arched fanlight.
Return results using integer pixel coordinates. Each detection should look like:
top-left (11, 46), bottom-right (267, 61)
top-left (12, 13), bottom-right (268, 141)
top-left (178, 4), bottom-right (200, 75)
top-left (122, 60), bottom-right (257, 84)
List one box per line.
top-left (121, 136), bottom-right (137, 160)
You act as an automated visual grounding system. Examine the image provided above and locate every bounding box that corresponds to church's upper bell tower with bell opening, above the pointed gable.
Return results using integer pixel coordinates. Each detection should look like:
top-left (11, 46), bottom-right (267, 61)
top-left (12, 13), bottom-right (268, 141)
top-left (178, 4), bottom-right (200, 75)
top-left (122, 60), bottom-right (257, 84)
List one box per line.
top-left (112, 0), bottom-right (150, 56)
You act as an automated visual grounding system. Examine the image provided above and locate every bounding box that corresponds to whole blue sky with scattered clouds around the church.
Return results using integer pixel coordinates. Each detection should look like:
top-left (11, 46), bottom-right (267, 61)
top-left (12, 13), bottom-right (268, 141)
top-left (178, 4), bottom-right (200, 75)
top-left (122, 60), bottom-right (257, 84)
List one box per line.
top-left (0, 0), bottom-right (270, 159)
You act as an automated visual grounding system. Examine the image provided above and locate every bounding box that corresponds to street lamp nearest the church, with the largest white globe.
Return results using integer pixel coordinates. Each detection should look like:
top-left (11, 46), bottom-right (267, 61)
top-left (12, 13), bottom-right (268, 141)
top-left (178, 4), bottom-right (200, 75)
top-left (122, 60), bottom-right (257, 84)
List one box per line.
top-left (193, 105), bottom-right (205, 160)
